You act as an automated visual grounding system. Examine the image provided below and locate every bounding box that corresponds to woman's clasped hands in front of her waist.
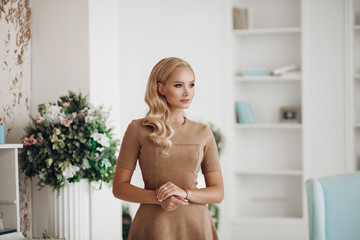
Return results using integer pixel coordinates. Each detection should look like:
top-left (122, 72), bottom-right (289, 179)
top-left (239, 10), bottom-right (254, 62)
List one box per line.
top-left (156, 182), bottom-right (189, 211)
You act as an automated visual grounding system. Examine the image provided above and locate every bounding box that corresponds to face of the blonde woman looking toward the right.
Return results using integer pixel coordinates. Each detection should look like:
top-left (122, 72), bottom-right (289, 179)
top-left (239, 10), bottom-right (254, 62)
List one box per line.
top-left (158, 67), bottom-right (195, 109)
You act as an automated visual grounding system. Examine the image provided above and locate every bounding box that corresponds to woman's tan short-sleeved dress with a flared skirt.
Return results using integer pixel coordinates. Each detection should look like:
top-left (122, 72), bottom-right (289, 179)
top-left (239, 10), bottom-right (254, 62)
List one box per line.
top-left (117, 115), bottom-right (221, 240)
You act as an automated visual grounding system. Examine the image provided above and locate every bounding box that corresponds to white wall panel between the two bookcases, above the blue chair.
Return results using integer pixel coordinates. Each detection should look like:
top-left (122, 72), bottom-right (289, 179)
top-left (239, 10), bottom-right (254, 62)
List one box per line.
top-left (303, 0), bottom-right (346, 180)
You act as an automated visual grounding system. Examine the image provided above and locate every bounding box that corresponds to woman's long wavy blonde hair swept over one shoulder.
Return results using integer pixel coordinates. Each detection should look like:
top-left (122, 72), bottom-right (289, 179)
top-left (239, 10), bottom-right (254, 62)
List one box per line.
top-left (142, 57), bottom-right (195, 155)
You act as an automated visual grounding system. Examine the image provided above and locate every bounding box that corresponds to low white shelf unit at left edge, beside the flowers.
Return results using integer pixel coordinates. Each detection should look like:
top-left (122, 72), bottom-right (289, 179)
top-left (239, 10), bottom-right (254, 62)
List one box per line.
top-left (0, 144), bottom-right (25, 240)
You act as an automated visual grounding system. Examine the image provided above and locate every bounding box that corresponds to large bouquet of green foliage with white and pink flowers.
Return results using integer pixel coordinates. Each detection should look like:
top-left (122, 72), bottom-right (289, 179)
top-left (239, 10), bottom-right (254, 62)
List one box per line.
top-left (19, 91), bottom-right (119, 190)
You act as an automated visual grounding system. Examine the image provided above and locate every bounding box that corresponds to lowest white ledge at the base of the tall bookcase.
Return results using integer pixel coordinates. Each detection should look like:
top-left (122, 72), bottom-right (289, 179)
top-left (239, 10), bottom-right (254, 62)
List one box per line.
top-left (230, 217), bottom-right (307, 226)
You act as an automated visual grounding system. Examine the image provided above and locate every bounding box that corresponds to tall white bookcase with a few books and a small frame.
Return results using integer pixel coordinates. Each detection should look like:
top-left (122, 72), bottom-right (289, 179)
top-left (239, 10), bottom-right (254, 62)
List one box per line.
top-left (227, 0), bottom-right (307, 239)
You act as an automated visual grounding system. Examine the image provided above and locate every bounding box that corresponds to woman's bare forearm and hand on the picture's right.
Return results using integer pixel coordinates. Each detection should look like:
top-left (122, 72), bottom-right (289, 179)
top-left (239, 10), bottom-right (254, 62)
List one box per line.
top-left (157, 171), bottom-right (224, 204)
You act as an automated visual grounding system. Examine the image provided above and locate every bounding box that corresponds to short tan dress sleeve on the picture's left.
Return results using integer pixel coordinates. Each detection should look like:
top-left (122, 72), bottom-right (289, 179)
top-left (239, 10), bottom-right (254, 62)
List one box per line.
top-left (117, 120), bottom-right (140, 171)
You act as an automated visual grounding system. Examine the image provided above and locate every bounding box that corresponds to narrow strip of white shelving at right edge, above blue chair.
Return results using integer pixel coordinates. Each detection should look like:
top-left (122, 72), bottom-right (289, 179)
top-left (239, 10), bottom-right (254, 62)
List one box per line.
top-left (347, 0), bottom-right (360, 172)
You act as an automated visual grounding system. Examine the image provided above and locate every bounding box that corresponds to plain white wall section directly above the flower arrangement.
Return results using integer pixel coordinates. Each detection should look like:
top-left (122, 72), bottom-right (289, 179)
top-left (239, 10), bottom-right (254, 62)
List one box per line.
top-left (31, 0), bottom-right (89, 116)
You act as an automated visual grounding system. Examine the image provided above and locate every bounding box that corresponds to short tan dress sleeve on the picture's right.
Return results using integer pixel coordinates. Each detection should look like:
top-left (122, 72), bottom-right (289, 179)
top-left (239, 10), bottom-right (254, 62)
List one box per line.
top-left (201, 127), bottom-right (221, 174)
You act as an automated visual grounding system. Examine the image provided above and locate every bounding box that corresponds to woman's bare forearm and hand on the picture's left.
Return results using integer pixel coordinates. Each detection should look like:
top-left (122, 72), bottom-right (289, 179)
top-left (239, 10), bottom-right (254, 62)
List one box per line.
top-left (113, 167), bottom-right (188, 211)
